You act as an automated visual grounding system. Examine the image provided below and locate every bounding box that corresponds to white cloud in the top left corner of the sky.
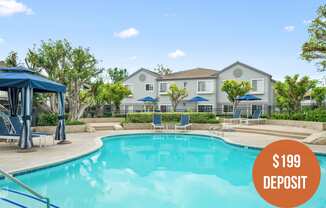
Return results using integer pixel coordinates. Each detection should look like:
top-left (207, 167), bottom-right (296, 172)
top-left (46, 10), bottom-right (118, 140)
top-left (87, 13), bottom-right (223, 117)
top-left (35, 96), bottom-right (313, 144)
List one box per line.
top-left (0, 0), bottom-right (33, 16)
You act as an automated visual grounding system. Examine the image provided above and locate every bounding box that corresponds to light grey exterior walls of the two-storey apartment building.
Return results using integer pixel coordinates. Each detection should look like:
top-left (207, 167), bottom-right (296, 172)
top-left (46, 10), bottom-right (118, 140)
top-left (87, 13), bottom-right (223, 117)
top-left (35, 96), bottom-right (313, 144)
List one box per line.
top-left (121, 64), bottom-right (275, 113)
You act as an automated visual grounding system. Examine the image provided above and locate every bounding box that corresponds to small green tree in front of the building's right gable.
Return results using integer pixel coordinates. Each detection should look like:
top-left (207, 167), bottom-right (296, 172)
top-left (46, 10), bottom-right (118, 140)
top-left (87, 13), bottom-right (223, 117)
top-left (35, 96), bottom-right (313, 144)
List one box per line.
top-left (222, 80), bottom-right (251, 110)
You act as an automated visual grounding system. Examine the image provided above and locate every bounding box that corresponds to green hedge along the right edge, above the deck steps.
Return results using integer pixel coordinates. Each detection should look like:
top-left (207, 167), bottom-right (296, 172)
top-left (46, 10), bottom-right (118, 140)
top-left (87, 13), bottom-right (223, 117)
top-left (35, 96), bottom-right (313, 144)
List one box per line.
top-left (271, 108), bottom-right (326, 122)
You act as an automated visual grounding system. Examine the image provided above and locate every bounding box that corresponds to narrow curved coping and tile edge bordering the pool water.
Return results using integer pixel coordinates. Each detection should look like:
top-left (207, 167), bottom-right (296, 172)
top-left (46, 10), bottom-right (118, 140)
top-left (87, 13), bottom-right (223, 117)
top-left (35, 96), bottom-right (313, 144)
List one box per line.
top-left (0, 130), bottom-right (326, 180)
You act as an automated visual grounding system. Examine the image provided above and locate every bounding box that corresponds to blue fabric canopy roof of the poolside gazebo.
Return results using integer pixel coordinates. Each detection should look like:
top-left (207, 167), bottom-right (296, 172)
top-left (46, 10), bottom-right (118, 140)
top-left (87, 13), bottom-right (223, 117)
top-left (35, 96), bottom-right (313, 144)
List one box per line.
top-left (0, 68), bottom-right (66, 93)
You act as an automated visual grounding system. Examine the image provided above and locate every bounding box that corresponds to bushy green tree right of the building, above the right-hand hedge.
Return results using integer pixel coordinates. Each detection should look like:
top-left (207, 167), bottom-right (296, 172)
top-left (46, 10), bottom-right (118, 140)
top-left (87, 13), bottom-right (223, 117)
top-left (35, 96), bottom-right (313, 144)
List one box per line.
top-left (274, 74), bottom-right (317, 113)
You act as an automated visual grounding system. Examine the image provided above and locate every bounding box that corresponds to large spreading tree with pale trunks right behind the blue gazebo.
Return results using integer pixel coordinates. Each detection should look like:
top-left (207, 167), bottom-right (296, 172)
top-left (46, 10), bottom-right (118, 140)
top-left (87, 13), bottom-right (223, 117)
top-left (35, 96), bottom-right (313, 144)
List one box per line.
top-left (25, 39), bottom-right (103, 120)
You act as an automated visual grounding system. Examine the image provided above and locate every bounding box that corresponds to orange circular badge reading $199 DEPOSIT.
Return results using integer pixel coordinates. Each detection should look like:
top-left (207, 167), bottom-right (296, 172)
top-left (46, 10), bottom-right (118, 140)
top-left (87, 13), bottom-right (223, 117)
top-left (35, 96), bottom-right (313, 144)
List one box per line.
top-left (253, 140), bottom-right (320, 207)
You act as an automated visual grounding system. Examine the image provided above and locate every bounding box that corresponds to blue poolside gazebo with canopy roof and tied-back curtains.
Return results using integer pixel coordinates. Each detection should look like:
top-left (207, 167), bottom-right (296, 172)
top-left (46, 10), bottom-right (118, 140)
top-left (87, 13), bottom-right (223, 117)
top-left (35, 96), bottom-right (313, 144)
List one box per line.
top-left (0, 68), bottom-right (66, 149)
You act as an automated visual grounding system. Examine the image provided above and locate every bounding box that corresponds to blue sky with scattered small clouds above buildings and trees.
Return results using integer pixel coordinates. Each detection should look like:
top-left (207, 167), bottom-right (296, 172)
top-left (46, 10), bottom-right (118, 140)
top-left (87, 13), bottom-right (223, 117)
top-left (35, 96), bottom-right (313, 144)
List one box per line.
top-left (0, 0), bottom-right (324, 79)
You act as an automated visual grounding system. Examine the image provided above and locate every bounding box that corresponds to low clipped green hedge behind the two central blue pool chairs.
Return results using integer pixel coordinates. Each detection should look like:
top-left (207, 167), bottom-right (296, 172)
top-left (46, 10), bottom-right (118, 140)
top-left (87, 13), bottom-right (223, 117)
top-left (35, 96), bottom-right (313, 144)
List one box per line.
top-left (126, 112), bottom-right (219, 123)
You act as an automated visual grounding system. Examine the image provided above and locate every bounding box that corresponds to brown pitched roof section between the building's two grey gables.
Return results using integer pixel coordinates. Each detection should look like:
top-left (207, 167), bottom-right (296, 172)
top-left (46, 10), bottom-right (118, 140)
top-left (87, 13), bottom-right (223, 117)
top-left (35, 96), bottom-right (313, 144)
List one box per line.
top-left (159, 68), bottom-right (218, 80)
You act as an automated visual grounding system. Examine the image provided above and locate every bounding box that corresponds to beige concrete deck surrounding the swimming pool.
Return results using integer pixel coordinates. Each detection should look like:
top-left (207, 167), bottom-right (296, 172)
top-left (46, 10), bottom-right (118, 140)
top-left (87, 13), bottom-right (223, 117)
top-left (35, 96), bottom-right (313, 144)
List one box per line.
top-left (0, 130), bottom-right (326, 174)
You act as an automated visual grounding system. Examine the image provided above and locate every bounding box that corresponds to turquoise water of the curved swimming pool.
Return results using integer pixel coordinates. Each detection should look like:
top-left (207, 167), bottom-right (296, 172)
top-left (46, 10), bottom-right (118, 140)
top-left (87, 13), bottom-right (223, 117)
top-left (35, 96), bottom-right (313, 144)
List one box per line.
top-left (0, 134), bottom-right (326, 208)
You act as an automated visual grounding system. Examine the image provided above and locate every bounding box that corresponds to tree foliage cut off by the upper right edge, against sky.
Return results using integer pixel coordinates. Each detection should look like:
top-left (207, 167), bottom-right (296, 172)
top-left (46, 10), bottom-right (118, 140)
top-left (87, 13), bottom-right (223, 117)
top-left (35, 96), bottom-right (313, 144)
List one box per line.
top-left (301, 4), bottom-right (326, 71)
